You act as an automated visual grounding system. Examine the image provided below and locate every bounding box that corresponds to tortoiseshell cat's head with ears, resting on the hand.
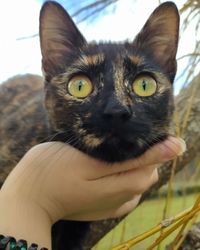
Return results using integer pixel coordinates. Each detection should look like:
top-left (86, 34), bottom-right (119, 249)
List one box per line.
top-left (40, 1), bottom-right (179, 162)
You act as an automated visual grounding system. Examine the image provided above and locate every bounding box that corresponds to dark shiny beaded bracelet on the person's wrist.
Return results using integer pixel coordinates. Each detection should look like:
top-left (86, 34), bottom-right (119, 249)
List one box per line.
top-left (0, 234), bottom-right (48, 250)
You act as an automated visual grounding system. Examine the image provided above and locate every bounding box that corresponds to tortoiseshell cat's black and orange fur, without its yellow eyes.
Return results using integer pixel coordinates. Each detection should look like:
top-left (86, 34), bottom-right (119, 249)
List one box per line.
top-left (0, 1), bottom-right (179, 250)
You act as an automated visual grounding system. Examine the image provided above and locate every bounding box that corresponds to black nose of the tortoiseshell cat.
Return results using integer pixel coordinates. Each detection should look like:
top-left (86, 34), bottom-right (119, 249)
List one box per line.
top-left (103, 98), bottom-right (131, 122)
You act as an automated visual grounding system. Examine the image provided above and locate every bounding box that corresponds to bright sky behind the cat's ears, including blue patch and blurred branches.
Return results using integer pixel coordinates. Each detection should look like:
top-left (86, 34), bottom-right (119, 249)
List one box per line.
top-left (0, 0), bottom-right (200, 94)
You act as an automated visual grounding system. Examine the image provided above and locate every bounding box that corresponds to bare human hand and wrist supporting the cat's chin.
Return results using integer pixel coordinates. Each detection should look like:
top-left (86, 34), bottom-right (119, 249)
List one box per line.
top-left (0, 137), bottom-right (185, 249)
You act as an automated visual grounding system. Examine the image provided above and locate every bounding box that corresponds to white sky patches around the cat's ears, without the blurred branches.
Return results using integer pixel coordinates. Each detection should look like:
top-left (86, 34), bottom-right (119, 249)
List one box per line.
top-left (0, 0), bottom-right (195, 92)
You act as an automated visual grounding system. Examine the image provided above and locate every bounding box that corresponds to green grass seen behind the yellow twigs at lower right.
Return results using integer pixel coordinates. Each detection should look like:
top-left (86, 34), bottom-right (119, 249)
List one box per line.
top-left (93, 195), bottom-right (196, 250)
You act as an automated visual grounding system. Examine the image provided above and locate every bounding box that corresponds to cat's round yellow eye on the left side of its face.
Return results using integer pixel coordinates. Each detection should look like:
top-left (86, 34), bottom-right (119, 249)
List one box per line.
top-left (68, 75), bottom-right (93, 98)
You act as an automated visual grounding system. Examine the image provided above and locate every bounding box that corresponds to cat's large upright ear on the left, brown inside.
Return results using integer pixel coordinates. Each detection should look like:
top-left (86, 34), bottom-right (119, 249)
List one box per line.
top-left (40, 1), bottom-right (86, 76)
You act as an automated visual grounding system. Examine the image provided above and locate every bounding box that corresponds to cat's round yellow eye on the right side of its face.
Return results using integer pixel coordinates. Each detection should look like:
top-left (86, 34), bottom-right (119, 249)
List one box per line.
top-left (132, 75), bottom-right (157, 97)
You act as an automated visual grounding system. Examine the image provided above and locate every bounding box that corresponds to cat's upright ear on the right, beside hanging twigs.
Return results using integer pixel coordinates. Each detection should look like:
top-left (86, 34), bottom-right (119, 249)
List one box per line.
top-left (134, 2), bottom-right (179, 81)
